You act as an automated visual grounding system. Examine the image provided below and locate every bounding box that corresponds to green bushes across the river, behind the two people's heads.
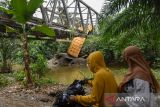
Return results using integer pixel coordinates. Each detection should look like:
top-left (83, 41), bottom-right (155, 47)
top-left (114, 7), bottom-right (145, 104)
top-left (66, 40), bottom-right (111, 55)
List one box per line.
top-left (80, 34), bottom-right (160, 68)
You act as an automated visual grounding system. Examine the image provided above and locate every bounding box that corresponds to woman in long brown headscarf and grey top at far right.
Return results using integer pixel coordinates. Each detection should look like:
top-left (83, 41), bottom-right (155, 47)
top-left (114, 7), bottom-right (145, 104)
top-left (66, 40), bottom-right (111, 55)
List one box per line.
top-left (119, 46), bottom-right (159, 107)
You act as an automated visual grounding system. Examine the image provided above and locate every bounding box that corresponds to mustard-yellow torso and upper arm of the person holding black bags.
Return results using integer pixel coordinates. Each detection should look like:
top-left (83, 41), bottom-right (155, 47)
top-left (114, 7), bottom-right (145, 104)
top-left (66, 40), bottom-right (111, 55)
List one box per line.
top-left (93, 68), bottom-right (118, 107)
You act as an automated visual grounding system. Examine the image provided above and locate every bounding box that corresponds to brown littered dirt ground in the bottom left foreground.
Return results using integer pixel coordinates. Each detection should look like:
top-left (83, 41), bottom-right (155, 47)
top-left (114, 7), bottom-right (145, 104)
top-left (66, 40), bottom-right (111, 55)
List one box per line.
top-left (0, 83), bottom-right (67, 107)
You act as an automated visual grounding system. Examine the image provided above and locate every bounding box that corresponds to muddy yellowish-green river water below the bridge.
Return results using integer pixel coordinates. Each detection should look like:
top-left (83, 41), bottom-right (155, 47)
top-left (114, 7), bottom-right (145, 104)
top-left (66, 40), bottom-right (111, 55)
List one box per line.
top-left (46, 67), bottom-right (126, 84)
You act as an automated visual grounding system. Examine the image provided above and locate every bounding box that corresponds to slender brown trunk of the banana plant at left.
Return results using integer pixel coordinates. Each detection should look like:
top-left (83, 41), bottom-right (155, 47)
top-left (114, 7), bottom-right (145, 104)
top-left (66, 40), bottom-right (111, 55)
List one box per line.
top-left (22, 26), bottom-right (33, 84)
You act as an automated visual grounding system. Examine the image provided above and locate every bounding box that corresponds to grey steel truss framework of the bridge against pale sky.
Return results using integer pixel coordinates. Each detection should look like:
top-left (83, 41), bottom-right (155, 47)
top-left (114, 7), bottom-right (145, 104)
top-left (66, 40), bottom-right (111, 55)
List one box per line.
top-left (0, 0), bottom-right (99, 38)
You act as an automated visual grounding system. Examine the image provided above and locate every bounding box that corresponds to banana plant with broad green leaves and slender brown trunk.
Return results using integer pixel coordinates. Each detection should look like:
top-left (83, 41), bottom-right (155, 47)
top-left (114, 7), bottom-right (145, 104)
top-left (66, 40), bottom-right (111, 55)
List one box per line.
top-left (11, 0), bottom-right (55, 85)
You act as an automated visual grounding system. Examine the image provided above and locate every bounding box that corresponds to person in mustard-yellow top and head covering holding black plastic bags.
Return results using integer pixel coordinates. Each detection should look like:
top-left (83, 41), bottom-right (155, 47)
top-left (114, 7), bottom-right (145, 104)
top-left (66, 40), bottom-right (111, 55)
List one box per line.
top-left (70, 51), bottom-right (118, 107)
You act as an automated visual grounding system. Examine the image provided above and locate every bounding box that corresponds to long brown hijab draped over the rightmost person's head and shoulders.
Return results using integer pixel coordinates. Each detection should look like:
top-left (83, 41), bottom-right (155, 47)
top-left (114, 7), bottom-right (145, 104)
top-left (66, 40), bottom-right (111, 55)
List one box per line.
top-left (120, 46), bottom-right (159, 92)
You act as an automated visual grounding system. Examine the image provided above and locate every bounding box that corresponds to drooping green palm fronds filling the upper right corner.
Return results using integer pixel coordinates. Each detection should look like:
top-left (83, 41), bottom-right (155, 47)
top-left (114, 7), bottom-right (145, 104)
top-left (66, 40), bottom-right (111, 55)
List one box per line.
top-left (100, 0), bottom-right (160, 66)
